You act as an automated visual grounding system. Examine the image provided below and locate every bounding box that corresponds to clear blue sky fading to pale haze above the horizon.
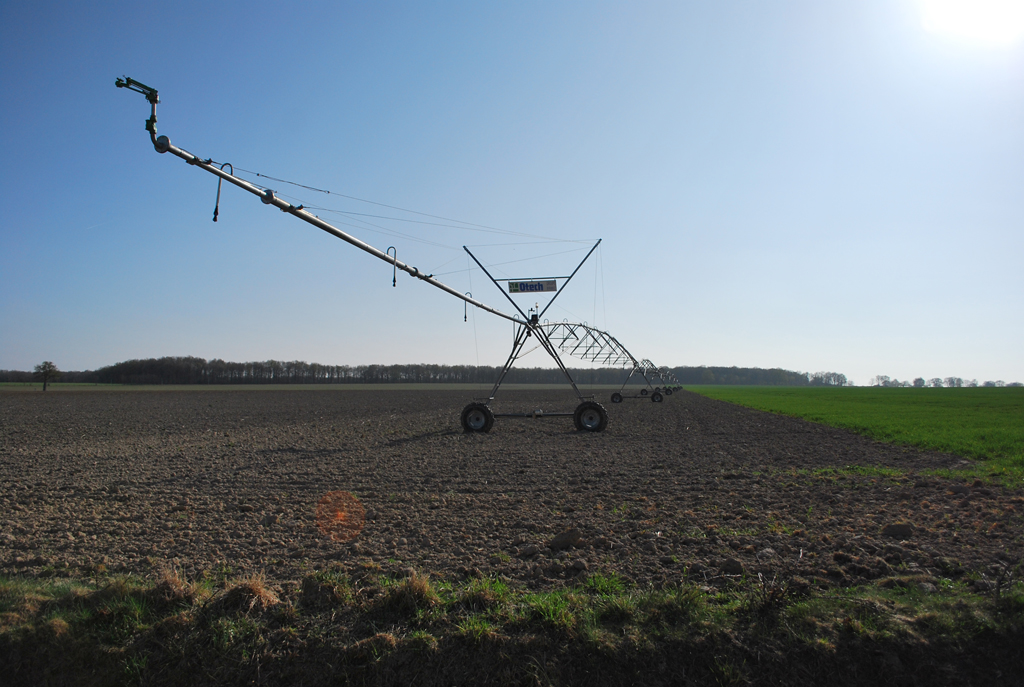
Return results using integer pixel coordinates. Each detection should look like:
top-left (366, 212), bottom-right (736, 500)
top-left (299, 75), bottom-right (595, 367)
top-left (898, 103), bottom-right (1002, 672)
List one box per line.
top-left (0, 0), bottom-right (1024, 384)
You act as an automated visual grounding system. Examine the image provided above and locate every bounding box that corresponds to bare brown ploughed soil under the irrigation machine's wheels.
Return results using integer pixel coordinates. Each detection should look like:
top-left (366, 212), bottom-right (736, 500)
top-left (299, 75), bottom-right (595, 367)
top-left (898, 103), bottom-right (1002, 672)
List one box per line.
top-left (0, 387), bottom-right (1024, 590)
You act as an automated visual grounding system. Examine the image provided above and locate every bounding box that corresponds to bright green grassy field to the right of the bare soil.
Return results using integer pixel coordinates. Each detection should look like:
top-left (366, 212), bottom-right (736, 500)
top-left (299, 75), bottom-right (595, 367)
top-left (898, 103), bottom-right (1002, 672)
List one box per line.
top-left (686, 386), bottom-right (1024, 486)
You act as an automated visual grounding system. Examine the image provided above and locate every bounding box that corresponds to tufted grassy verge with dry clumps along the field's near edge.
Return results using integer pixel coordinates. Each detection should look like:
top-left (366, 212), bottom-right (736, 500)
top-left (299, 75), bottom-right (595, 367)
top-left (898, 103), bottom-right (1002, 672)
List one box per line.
top-left (0, 562), bottom-right (1024, 686)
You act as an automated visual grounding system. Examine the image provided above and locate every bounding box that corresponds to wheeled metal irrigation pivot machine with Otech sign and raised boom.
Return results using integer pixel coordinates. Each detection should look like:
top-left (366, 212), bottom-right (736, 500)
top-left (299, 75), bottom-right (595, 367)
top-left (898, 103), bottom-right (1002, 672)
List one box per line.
top-left (115, 77), bottom-right (671, 432)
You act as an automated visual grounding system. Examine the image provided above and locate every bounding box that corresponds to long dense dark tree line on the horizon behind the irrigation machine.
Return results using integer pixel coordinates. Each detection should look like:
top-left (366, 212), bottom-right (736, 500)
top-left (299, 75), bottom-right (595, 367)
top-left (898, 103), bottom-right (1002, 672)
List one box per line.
top-left (0, 356), bottom-right (848, 386)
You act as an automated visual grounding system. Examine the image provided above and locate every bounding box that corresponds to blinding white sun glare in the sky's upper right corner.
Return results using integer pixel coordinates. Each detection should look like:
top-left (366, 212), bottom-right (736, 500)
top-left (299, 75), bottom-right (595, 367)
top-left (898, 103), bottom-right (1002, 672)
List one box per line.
top-left (918, 0), bottom-right (1024, 45)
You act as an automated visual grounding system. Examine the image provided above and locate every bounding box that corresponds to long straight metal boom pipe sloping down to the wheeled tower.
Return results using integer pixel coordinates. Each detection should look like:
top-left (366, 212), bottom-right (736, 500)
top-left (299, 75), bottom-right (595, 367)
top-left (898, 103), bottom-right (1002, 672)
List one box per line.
top-left (153, 136), bottom-right (526, 325)
